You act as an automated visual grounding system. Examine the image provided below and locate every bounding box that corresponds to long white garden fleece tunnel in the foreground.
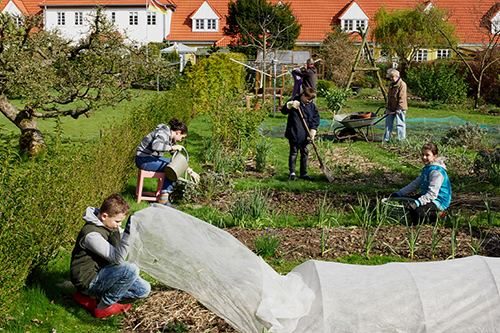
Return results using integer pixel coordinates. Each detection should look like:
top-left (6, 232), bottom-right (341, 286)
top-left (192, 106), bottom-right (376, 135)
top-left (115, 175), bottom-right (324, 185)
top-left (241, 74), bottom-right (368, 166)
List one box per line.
top-left (130, 204), bottom-right (500, 333)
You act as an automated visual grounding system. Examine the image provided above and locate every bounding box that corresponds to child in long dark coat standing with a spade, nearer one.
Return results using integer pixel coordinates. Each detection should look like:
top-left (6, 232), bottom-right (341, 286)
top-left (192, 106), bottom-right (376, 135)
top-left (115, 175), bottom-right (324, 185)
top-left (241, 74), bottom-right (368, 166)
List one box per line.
top-left (281, 88), bottom-right (319, 181)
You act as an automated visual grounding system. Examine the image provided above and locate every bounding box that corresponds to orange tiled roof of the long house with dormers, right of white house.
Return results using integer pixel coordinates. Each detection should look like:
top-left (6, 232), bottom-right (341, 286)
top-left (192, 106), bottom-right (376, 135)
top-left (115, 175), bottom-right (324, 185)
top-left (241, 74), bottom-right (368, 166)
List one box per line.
top-left (167, 0), bottom-right (496, 43)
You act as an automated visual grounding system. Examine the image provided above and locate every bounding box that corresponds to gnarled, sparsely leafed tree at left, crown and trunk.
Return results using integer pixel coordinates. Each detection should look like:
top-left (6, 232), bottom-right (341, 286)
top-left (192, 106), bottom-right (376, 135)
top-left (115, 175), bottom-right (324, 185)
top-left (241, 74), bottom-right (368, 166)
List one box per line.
top-left (0, 7), bottom-right (144, 154)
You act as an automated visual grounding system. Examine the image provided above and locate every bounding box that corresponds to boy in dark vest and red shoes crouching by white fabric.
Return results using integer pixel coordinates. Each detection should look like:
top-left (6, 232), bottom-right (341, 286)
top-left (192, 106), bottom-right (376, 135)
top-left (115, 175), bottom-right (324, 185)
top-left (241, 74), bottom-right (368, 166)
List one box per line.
top-left (70, 193), bottom-right (151, 318)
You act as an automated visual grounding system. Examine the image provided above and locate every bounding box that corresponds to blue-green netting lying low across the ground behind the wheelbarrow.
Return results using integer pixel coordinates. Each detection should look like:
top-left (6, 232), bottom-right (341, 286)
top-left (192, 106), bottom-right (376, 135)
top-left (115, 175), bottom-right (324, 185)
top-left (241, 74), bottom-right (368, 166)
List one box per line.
top-left (258, 116), bottom-right (500, 143)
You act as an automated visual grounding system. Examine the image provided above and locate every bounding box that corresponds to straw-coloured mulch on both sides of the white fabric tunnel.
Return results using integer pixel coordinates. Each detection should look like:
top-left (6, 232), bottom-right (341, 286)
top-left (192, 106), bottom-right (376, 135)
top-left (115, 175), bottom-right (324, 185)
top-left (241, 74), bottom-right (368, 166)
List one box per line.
top-left (125, 225), bottom-right (500, 333)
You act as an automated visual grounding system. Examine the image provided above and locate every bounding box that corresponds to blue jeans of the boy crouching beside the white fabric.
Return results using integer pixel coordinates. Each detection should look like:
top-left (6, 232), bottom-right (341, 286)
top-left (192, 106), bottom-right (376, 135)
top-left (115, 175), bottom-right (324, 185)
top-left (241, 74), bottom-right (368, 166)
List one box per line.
top-left (84, 261), bottom-right (151, 306)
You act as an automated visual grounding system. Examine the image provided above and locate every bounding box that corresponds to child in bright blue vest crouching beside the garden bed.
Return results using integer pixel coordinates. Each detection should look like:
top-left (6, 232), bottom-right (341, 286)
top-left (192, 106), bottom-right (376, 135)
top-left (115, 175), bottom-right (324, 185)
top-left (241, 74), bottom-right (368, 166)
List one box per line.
top-left (390, 142), bottom-right (451, 221)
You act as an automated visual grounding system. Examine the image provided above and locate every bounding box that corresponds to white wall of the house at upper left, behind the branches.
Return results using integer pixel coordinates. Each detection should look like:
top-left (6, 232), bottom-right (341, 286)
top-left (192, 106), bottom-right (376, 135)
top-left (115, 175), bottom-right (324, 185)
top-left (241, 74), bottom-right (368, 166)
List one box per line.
top-left (44, 7), bottom-right (172, 44)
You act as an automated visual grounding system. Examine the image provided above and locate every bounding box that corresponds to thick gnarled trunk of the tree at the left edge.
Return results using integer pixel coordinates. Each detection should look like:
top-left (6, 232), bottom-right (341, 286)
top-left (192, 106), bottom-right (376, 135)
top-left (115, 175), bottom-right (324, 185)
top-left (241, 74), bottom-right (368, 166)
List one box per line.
top-left (0, 95), bottom-right (46, 155)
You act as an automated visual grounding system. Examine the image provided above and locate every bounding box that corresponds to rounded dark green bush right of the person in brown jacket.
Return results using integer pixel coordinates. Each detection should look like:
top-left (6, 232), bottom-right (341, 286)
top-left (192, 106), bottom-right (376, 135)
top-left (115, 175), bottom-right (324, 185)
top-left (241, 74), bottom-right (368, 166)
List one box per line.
top-left (406, 61), bottom-right (468, 104)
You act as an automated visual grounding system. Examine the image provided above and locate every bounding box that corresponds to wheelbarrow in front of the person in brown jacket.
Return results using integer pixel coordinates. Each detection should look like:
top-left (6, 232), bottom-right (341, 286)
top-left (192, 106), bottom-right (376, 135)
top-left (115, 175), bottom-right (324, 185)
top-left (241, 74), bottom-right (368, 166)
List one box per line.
top-left (333, 106), bottom-right (395, 143)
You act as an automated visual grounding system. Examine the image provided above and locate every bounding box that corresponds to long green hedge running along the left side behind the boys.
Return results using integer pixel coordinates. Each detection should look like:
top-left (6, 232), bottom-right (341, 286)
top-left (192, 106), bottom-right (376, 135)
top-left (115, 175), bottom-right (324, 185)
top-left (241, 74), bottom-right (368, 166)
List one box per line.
top-left (0, 91), bottom-right (191, 318)
